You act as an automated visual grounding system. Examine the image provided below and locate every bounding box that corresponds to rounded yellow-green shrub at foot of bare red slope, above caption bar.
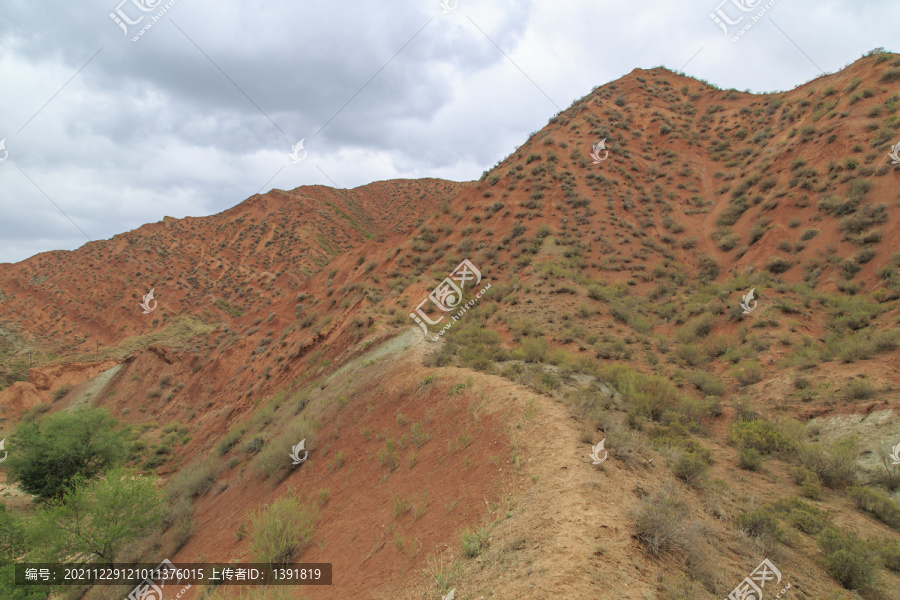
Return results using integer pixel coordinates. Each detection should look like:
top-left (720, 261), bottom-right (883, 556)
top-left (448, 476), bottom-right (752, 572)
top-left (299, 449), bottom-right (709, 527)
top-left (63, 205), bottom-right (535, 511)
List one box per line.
top-left (250, 496), bottom-right (319, 565)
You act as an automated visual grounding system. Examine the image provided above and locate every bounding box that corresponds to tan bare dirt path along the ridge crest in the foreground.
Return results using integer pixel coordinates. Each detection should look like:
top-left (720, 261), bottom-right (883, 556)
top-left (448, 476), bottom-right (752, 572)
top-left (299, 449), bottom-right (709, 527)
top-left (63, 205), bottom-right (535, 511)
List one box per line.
top-left (404, 332), bottom-right (659, 600)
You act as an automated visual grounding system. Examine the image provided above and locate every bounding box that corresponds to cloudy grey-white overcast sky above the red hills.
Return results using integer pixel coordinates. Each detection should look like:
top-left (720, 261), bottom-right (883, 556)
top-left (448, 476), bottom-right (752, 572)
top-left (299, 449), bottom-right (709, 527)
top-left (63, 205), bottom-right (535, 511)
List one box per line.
top-left (0, 0), bottom-right (900, 262)
